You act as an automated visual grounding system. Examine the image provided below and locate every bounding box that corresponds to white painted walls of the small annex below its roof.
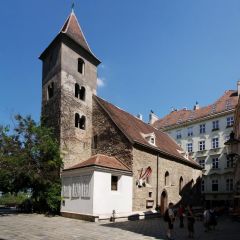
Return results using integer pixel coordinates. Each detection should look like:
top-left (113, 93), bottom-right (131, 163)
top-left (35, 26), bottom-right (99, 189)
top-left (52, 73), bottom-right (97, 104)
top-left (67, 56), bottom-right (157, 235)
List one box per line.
top-left (61, 168), bottom-right (132, 216)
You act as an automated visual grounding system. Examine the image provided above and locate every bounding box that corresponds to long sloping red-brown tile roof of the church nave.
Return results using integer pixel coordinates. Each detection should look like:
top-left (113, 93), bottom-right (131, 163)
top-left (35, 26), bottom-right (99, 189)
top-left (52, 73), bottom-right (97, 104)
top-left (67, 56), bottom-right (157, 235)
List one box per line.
top-left (94, 96), bottom-right (200, 168)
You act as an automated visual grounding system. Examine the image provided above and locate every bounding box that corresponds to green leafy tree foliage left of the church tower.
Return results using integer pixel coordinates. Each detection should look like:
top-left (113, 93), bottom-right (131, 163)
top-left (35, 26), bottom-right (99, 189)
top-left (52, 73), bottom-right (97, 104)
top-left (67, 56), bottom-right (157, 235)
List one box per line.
top-left (0, 115), bottom-right (62, 211)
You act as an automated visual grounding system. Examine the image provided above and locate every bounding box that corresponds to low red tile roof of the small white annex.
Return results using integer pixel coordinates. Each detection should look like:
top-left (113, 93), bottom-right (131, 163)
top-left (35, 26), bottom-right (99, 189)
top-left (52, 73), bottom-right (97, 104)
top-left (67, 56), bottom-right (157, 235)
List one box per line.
top-left (63, 154), bottom-right (130, 172)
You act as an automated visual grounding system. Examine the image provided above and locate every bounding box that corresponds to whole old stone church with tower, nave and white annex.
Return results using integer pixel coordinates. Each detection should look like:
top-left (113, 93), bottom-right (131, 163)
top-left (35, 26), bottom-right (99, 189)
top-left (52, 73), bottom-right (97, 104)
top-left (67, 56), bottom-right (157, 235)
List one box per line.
top-left (40, 11), bottom-right (202, 221)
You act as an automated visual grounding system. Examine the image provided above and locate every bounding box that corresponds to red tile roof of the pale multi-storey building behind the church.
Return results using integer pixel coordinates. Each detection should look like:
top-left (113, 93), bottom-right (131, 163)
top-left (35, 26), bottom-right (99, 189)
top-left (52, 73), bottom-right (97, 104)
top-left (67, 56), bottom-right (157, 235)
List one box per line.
top-left (153, 90), bottom-right (238, 129)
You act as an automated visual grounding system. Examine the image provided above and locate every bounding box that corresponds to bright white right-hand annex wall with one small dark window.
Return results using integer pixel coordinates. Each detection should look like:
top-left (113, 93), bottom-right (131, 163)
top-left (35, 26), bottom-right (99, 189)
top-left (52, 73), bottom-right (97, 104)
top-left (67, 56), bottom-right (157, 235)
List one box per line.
top-left (93, 171), bottom-right (132, 215)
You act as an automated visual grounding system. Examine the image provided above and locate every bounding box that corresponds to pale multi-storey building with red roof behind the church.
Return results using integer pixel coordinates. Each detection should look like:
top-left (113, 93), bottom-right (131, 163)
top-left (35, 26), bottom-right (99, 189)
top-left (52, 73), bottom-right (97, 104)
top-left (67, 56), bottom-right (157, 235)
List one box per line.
top-left (153, 91), bottom-right (238, 205)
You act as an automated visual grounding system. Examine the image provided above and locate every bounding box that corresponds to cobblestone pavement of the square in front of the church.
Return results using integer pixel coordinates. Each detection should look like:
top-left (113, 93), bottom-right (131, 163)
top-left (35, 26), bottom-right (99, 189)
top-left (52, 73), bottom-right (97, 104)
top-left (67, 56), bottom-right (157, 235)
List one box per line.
top-left (0, 214), bottom-right (240, 240)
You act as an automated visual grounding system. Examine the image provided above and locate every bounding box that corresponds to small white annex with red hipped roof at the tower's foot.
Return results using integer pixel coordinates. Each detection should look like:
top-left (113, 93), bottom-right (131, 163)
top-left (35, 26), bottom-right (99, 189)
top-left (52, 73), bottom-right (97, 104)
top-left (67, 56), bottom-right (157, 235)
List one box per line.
top-left (61, 155), bottom-right (133, 221)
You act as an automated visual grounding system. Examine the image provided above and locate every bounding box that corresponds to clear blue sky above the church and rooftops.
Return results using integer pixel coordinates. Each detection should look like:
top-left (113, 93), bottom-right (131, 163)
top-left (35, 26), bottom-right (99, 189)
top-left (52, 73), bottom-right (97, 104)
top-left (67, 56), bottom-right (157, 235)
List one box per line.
top-left (0, 0), bottom-right (240, 124)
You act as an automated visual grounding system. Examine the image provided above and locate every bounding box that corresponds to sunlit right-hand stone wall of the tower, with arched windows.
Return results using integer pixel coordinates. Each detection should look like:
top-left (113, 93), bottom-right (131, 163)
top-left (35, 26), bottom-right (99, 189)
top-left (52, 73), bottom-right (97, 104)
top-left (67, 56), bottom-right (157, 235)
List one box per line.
top-left (60, 44), bottom-right (97, 168)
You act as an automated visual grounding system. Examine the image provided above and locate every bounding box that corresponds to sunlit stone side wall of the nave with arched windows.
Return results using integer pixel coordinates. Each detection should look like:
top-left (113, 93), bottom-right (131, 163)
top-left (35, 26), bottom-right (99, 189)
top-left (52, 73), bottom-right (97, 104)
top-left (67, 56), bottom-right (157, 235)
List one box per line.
top-left (133, 148), bottom-right (201, 211)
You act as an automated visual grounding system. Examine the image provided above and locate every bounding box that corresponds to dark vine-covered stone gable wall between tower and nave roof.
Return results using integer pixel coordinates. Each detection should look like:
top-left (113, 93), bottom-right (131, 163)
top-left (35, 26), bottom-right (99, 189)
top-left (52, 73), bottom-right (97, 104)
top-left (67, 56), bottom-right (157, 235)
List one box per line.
top-left (92, 99), bottom-right (132, 169)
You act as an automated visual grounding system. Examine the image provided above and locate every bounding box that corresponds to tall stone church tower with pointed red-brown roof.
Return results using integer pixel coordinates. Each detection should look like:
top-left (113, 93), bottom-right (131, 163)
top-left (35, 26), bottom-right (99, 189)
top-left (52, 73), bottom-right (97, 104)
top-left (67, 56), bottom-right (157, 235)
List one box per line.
top-left (40, 11), bottom-right (100, 168)
